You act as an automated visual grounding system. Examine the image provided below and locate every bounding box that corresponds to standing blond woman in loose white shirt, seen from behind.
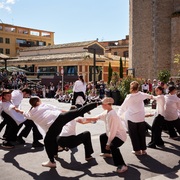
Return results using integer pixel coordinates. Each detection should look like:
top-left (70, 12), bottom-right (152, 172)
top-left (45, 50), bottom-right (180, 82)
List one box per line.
top-left (118, 81), bottom-right (151, 155)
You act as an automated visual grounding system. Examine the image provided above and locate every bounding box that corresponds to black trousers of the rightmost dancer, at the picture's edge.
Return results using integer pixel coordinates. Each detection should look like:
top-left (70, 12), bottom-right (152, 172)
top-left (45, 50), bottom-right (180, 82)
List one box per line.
top-left (166, 118), bottom-right (180, 138)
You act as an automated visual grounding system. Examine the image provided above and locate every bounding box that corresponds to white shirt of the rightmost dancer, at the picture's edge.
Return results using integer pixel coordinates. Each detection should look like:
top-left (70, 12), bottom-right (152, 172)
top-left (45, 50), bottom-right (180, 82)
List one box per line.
top-left (164, 94), bottom-right (180, 121)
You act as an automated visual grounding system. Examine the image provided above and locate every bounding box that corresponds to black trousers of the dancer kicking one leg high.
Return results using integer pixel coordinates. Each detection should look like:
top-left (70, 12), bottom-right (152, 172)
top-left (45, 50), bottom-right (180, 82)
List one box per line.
top-left (44, 103), bottom-right (97, 161)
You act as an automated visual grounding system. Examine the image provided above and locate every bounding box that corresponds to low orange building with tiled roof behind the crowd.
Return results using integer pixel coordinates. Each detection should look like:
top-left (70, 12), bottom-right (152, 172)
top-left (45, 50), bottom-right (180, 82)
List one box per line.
top-left (1, 41), bottom-right (128, 82)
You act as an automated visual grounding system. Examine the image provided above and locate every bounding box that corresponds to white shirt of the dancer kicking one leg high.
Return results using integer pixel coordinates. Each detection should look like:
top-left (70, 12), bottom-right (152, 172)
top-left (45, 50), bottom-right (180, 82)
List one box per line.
top-left (24, 103), bottom-right (62, 132)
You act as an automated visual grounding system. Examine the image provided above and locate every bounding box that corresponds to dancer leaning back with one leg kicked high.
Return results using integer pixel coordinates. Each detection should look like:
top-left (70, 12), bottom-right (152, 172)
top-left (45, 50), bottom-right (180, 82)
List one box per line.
top-left (16, 96), bottom-right (100, 168)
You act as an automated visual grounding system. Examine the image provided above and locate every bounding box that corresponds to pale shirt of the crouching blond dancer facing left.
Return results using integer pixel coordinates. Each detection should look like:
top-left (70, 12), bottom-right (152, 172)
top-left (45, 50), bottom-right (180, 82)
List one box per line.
top-left (97, 110), bottom-right (127, 145)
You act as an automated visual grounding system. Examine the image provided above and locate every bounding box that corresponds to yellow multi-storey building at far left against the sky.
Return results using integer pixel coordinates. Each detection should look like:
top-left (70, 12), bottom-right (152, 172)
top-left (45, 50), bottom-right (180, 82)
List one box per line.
top-left (0, 23), bottom-right (54, 57)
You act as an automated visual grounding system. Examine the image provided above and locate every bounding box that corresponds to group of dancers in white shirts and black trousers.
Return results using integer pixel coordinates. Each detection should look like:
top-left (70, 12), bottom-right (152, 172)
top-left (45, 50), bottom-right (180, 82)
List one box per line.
top-left (2, 76), bottom-right (180, 173)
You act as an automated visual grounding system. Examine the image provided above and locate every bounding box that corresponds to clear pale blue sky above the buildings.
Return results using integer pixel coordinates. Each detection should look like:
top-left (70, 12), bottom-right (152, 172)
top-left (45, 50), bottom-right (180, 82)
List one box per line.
top-left (0, 0), bottom-right (129, 44)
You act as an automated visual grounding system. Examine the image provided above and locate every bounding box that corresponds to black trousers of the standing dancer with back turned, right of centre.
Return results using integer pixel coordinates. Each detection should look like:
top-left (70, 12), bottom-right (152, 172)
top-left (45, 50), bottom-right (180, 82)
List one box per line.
top-left (128, 120), bottom-right (146, 151)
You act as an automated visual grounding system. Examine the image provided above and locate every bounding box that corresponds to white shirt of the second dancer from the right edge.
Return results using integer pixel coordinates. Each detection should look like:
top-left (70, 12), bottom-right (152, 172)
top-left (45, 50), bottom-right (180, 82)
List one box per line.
top-left (153, 95), bottom-right (165, 117)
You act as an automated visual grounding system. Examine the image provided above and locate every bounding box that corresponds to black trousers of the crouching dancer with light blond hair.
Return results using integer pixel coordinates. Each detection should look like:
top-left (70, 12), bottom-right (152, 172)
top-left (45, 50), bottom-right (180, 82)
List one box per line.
top-left (100, 133), bottom-right (126, 166)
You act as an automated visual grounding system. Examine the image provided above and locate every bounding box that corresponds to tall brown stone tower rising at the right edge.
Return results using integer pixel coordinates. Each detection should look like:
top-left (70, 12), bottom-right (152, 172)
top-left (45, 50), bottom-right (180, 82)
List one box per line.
top-left (129, 0), bottom-right (180, 79)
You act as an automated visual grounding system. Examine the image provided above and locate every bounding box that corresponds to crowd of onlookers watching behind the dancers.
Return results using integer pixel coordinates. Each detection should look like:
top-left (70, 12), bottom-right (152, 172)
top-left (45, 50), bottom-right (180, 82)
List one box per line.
top-left (0, 70), bottom-right (180, 104)
